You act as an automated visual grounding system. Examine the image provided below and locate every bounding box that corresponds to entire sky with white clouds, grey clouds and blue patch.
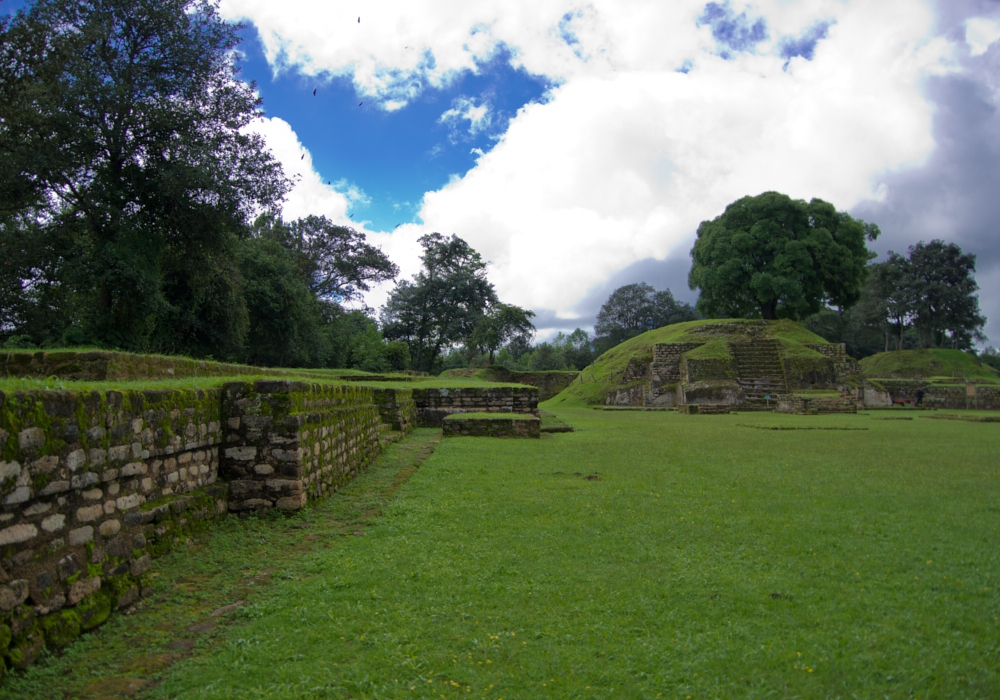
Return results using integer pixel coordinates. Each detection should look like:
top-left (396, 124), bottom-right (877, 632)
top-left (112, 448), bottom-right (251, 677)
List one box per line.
top-left (0, 0), bottom-right (1000, 345)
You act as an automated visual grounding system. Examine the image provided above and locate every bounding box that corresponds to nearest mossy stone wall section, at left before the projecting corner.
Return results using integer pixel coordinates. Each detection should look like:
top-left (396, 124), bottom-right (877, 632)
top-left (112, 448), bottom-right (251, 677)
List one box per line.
top-left (0, 390), bottom-right (227, 668)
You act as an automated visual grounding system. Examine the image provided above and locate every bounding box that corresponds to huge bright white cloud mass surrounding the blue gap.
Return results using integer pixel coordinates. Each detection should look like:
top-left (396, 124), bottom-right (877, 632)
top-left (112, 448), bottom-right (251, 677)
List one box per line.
top-left (230, 0), bottom-right (955, 334)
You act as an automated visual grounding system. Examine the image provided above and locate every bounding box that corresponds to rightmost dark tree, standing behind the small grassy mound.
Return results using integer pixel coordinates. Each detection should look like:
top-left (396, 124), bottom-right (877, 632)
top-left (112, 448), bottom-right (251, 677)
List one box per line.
top-left (907, 240), bottom-right (986, 350)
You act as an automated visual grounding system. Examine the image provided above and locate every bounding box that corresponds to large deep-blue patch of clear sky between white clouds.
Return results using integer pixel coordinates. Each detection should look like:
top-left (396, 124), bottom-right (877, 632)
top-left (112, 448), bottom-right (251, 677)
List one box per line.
top-left (241, 25), bottom-right (550, 231)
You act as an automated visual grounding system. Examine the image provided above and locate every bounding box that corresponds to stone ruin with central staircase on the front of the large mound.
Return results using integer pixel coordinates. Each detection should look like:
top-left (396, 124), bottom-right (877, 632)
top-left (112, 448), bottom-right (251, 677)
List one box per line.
top-left (605, 321), bottom-right (861, 413)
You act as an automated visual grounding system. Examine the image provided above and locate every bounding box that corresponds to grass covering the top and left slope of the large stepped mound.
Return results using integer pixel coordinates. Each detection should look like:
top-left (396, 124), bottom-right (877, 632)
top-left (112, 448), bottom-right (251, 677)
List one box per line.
top-left (552, 318), bottom-right (827, 404)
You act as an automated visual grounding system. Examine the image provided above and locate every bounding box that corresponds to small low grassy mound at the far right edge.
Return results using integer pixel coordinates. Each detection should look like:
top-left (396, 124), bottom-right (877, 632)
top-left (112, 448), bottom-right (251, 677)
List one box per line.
top-left (860, 348), bottom-right (1000, 383)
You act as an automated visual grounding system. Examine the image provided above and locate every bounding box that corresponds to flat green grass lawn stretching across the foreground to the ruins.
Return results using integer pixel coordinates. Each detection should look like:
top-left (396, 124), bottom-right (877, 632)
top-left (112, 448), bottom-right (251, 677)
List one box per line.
top-left (2, 403), bottom-right (1000, 700)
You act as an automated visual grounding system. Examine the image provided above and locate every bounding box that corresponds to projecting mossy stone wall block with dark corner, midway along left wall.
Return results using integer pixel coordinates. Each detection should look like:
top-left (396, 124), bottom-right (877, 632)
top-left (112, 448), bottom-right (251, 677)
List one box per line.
top-left (219, 380), bottom-right (381, 513)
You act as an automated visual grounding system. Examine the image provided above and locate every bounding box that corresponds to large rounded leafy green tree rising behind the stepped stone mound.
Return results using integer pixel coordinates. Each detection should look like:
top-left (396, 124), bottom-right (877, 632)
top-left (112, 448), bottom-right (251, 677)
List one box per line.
top-left (688, 192), bottom-right (879, 319)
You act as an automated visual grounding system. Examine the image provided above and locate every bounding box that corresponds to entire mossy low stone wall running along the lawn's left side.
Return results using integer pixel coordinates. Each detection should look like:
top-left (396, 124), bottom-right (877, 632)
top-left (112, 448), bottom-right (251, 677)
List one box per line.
top-left (0, 379), bottom-right (539, 677)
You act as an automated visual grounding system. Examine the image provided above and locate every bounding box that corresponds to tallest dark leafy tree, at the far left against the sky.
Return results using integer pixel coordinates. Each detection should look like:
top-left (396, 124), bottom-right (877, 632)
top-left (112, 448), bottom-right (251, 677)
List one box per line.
top-left (0, 0), bottom-right (289, 350)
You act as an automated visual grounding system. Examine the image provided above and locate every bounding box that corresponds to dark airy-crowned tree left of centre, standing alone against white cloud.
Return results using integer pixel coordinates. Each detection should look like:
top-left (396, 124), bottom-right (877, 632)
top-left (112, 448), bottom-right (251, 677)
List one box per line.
top-left (381, 233), bottom-right (499, 371)
